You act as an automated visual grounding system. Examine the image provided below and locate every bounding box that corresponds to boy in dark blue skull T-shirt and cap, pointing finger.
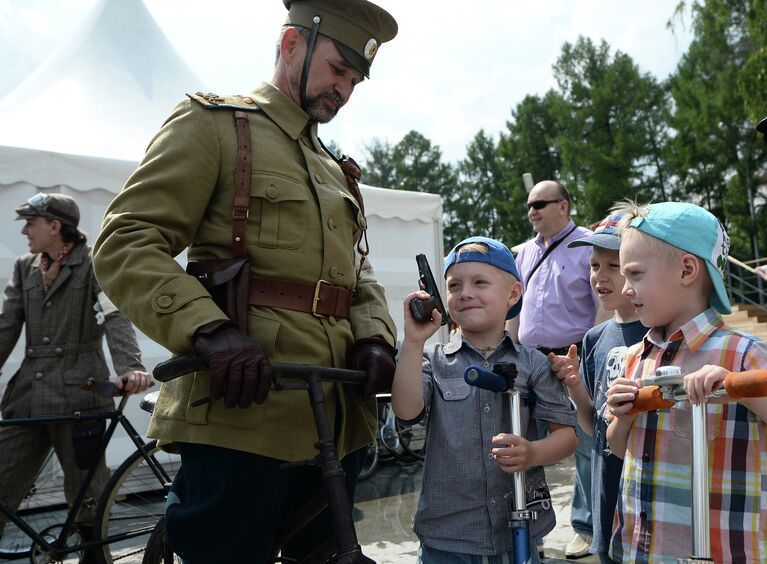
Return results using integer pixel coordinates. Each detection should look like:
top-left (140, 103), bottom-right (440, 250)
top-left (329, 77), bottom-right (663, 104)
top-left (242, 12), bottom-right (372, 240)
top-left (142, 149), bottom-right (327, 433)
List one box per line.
top-left (549, 213), bottom-right (647, 564)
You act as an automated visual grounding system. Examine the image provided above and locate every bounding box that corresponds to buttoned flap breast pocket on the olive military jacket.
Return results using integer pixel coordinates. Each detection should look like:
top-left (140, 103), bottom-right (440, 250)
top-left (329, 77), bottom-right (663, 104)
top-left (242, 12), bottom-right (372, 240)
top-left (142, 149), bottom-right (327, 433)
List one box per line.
top-left (254, 175), bottom-right (309, 249)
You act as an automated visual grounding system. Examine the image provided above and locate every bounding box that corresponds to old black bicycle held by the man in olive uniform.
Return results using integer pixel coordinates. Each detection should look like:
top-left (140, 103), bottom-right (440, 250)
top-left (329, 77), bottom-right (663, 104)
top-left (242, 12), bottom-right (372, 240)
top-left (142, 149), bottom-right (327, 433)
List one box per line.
top-left (143, 354), bottom-right (375, 564)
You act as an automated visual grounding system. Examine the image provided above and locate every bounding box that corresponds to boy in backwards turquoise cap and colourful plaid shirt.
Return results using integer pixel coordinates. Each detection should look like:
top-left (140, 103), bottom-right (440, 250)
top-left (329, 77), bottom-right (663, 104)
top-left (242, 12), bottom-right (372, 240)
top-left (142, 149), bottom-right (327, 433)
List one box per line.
top-left (607, 202), bottom-right (767, 563)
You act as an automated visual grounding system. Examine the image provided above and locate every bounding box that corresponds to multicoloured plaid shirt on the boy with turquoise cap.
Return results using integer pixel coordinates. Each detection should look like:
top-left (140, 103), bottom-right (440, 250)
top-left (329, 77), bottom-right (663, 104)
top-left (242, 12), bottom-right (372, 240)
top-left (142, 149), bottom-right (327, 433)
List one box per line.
top-left (611, 308), bottom-right (767, 563)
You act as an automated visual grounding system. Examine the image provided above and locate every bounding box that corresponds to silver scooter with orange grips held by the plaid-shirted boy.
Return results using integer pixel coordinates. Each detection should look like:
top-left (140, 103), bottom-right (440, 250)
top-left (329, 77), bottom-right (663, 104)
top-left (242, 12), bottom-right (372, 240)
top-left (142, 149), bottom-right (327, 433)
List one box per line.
top-left (628, 366), bottom-right (767, 563)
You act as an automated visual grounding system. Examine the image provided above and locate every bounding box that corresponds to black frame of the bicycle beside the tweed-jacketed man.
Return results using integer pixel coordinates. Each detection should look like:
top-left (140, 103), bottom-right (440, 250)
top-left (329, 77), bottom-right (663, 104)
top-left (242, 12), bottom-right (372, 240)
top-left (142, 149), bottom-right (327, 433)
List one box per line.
top-left (0, 395), bottom-right (169, 558)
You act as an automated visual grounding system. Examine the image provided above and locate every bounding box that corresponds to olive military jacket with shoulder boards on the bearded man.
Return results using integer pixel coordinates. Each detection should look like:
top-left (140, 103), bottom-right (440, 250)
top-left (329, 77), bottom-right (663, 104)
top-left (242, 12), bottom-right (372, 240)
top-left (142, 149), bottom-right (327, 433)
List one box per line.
top-left (95, 84), bottom-right (396, 460)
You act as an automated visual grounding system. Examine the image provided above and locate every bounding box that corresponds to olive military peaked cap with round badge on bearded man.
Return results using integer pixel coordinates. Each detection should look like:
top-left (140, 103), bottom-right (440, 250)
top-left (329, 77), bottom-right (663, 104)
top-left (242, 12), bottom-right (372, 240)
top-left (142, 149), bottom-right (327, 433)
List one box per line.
top-left (282, 0), bottom-right (397, 78)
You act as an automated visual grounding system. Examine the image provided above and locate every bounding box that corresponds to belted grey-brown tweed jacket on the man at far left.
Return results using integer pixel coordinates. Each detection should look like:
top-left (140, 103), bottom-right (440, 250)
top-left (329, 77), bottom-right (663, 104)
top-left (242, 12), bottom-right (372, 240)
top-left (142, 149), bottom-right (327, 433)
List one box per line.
top-left (0, 244), bottom-right (144, 419)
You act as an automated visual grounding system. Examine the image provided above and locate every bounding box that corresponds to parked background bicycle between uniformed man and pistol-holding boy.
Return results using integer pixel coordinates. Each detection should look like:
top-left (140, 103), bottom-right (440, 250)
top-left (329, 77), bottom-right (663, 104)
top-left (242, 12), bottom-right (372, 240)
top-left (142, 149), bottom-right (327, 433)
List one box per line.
top-left (358, 394), bottom-right (426, 480)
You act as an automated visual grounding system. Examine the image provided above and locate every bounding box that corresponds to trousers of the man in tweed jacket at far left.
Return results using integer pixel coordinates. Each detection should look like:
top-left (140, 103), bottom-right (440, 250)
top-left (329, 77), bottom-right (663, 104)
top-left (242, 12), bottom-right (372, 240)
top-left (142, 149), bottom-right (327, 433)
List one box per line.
top-left (0, 414), bottom-right (109, 533)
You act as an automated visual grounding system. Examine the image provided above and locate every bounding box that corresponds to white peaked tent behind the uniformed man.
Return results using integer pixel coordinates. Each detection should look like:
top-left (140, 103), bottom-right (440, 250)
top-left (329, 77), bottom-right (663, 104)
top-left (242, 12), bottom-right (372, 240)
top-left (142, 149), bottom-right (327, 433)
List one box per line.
top-left (0, 0), bottom-right (446, 462)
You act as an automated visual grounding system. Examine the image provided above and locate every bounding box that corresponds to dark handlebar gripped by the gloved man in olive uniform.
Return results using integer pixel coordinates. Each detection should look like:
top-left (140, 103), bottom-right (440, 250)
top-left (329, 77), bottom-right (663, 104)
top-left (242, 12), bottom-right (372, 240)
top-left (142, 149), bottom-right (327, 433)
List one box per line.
top-left (152, 353), bottom-right (367, 388)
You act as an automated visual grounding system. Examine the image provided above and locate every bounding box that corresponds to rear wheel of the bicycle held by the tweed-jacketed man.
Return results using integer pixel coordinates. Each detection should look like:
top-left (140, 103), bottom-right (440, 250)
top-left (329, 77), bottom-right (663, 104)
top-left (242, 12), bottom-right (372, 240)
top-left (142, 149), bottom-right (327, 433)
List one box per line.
top-left (0, 450), bottom-right (68, 560)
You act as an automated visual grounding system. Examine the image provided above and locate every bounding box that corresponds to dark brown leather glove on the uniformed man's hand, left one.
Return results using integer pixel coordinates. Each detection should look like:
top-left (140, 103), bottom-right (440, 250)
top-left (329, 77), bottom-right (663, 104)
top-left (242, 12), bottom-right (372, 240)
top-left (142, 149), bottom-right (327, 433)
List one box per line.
top-left (192, 321), bottom-right (272, 408)
